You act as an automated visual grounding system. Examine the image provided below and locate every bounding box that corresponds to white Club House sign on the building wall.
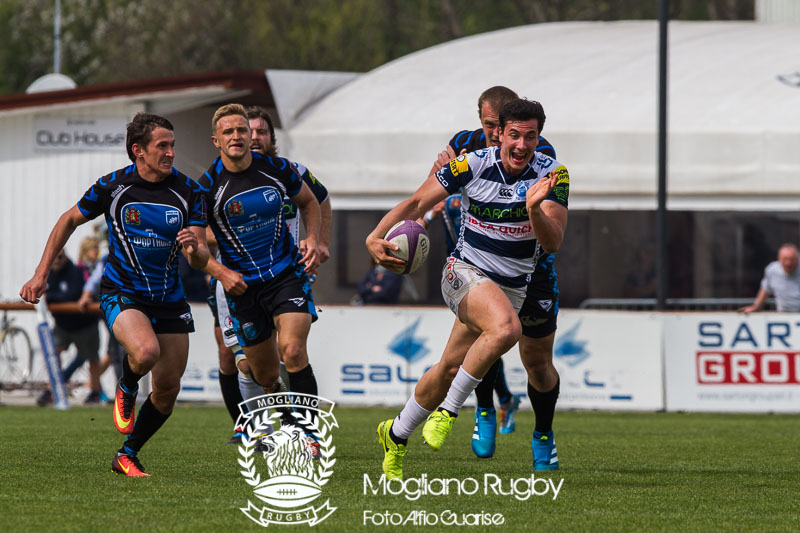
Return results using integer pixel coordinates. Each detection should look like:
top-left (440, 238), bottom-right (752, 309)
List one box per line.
top-left (33, 117), bottom-right (127, 152)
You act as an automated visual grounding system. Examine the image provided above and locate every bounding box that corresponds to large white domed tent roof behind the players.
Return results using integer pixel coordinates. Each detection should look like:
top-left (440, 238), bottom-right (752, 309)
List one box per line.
top-left (289, 21), bottom-right (800, 210)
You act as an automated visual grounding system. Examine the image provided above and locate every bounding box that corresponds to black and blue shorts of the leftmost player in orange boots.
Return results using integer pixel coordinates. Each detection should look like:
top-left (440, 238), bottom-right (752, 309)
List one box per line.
top-left (100, 293), bottom-right (194, 333)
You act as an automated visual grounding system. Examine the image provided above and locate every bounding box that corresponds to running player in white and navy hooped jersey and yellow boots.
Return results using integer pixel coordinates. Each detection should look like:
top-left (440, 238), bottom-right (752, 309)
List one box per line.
top-left (366, 100), bottom-right (567, 478)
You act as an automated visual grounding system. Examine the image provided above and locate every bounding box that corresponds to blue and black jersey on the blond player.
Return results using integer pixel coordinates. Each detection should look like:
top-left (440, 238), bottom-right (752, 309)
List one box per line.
top-left (198, 152), bottom-right (303, 284)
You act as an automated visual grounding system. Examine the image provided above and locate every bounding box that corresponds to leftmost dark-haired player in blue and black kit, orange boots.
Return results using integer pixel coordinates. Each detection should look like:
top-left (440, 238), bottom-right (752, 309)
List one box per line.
top-left (20, 113), bottom-right (208, 477)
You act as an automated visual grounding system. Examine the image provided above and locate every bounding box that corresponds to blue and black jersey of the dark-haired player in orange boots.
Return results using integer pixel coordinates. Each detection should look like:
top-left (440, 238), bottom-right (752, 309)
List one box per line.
top-left (78, 164), bottom-right (206, 302)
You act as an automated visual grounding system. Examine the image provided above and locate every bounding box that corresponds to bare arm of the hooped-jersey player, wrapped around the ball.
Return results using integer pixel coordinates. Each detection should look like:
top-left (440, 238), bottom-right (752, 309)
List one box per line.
top-left (365, 172), bottom-right (447, 272)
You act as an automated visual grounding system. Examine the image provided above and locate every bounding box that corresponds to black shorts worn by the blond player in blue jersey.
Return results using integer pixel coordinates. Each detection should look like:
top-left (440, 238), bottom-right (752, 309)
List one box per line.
top-left (225, 264), bottom-right (317, 346)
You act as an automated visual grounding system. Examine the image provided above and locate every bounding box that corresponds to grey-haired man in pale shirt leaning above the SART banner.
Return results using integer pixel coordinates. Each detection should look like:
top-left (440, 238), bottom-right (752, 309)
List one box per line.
top-left (739, 243), bottom-right (800, 314)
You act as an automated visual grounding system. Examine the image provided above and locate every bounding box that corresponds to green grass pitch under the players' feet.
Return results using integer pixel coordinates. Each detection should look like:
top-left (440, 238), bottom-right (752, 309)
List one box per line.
top-left (0, 406), bottom-right (800, 533)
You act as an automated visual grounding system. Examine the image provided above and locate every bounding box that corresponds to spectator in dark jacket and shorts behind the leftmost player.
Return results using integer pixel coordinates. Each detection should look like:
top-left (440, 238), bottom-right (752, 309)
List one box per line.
top-left (36, 250), bottom-right (100, 406)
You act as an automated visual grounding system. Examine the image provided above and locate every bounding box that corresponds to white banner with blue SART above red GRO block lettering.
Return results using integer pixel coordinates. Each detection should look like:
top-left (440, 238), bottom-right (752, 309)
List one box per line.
top-left (664, 313), bottom-right (800, 413)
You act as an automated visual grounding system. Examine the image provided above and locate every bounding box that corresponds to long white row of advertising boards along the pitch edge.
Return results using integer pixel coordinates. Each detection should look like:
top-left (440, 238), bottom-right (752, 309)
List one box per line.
top-left (180, 306), bottom-right (800, 412)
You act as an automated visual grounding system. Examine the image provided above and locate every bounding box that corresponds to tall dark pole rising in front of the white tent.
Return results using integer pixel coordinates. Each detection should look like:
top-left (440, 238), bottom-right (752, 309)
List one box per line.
top-left (656, 0), bottom-right (669, 311)
